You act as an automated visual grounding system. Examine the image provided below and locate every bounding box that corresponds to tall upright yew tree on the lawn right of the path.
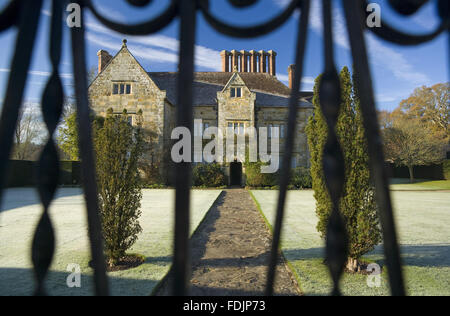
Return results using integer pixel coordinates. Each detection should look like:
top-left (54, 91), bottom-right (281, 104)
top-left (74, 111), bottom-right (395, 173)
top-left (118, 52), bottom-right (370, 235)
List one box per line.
top-left (306, 67), bottom-right (381, 271)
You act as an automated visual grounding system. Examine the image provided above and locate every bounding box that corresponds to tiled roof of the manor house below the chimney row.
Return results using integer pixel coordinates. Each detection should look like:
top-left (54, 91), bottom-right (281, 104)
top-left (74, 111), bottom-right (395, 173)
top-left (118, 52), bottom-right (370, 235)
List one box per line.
top-left (148, 72), bottom-right (312, 106)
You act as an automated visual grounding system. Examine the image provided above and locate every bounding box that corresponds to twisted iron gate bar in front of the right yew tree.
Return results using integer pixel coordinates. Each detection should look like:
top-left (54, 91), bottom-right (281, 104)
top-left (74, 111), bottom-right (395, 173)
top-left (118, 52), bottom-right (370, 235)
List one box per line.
top-left (319, 0), bottom-right (348, 296)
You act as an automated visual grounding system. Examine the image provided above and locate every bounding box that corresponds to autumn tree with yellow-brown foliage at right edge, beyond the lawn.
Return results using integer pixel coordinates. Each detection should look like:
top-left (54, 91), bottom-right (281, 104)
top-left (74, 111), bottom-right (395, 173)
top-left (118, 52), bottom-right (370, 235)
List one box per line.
top-left (379, 83), bottom-right (450, 182)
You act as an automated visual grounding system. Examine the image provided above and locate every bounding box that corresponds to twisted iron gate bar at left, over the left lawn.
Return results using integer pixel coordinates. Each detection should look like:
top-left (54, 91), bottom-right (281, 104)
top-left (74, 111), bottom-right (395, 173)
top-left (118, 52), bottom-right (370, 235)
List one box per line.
top-left (31, 0), bottom-right (65, 296)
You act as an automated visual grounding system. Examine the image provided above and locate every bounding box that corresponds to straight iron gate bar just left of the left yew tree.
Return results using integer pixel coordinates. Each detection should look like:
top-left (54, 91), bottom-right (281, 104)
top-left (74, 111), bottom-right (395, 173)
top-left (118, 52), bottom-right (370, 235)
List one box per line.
top-left (71, 0), bottom-right (109, 296)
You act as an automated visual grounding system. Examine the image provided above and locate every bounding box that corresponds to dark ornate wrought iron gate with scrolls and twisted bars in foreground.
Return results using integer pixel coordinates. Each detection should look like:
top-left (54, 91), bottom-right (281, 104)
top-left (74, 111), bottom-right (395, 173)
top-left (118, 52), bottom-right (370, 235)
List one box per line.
top-left (0, 0), bottom-right (449, 295)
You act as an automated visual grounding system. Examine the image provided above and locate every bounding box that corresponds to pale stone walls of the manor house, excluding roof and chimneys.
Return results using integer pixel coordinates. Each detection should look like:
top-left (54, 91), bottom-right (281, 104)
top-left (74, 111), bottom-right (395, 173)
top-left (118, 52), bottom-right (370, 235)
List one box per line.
top-left (89, 42), bottom-right (312, 182)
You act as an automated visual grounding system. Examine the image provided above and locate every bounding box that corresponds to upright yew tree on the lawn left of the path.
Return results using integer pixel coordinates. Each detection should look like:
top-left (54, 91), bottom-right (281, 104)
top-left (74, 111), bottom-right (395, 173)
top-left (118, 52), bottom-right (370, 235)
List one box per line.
top-left (95, 109), bottom-right (143, 265)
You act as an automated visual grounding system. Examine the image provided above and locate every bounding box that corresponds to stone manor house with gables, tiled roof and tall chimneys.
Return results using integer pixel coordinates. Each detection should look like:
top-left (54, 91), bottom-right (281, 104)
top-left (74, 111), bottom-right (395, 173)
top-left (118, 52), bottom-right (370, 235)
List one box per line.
top-left (89, 40), bottom-right (313, 185)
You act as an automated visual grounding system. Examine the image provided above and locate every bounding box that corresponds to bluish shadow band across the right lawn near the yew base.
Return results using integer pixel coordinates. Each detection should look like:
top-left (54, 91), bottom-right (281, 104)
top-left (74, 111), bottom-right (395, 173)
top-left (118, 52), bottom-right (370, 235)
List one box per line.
top-left (283, 244), bottom-right (450, 267)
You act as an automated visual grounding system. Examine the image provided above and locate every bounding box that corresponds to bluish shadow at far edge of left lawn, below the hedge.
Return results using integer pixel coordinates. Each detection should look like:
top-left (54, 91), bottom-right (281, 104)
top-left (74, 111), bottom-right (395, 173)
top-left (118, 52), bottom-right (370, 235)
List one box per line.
top-left (0, 187), bottom-right (84, 213)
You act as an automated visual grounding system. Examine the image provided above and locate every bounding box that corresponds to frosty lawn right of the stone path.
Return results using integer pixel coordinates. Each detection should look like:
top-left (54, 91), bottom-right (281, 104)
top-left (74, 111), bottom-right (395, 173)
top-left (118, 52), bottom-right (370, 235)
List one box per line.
top-left (252, 190), bottom-right (450, 295)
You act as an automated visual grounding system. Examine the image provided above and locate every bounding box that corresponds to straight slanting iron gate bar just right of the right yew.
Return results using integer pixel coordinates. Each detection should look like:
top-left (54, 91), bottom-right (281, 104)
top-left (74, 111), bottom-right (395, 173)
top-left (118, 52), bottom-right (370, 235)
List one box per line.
top-left (343, 0), bottom-right (405, 296)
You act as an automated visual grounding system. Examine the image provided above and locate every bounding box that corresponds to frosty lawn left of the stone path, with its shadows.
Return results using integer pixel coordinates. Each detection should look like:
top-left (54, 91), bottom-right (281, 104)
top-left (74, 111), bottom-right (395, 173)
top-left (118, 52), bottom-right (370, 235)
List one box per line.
top-left (0, 188), bottom-right (220, 295)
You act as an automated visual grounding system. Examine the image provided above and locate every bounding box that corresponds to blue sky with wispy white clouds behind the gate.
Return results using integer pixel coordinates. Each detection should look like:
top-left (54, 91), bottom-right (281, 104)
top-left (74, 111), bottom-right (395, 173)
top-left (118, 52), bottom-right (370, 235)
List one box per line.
top-left (0, 0), bottom-right (449, 110)
